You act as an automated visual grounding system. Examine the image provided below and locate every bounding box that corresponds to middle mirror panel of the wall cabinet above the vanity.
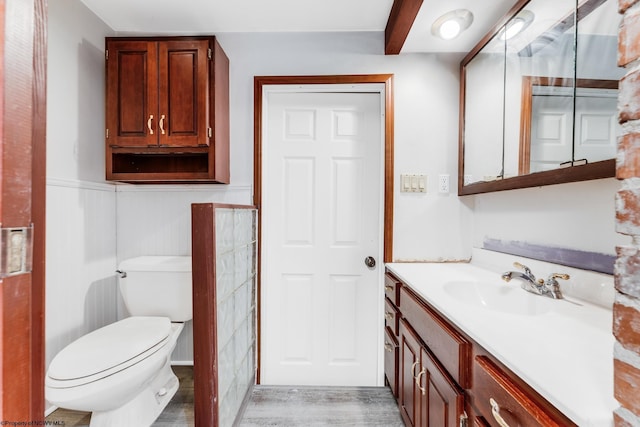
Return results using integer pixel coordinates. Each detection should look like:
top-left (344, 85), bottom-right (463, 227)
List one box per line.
top-left (505, 0), bottom-right (576, 178)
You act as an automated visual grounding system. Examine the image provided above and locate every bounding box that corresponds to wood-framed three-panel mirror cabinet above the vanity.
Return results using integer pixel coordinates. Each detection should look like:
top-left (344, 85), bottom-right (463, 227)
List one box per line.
top-left (458, 0), bottom-right (623, 195)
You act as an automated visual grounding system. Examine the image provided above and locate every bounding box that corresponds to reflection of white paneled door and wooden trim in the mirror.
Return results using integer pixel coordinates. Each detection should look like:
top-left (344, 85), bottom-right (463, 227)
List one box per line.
top-left (519, 76), bottom-right (619, 174)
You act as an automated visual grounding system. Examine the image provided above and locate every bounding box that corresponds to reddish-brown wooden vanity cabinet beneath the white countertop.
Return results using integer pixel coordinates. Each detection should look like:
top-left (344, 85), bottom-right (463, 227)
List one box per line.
top-left (385, 272), bottom-right (575, 427)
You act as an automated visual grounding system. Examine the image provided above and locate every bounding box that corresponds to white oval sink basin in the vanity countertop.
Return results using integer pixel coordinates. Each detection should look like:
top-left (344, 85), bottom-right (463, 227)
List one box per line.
top-left (443, 280), bottom-right (554, 316)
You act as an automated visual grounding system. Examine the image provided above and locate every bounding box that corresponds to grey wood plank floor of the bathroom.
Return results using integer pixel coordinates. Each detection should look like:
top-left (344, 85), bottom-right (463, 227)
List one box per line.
top-left (47, 366), bottom-right (404, 427)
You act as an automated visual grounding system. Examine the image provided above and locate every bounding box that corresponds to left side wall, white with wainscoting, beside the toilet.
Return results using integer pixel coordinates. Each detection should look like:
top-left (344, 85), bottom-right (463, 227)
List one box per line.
top-left (45, 0), bottom-right (117, 414)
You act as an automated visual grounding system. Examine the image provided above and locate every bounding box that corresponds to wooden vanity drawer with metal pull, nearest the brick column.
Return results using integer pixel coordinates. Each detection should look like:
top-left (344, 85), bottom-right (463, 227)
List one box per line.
top-left (473, 356), bottom-right (575, 426)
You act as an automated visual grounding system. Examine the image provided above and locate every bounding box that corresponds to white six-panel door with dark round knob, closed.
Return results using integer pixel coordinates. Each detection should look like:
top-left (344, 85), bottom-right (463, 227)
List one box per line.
top-left (261, 92), bottom-right (384, 385)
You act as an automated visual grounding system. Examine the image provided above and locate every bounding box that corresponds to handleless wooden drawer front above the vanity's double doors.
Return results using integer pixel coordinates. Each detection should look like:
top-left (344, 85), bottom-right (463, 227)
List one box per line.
top-left (400, 286), bottom-right (471, 389)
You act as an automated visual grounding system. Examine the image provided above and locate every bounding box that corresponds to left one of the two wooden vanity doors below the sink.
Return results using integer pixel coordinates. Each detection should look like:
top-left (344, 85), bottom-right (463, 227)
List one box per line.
top-left (398, 319), bottom-right (421, 427)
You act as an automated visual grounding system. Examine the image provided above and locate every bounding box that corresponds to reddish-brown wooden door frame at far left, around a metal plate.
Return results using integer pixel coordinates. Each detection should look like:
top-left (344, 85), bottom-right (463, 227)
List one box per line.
top-left (0, 0), bottom-right (47, 422)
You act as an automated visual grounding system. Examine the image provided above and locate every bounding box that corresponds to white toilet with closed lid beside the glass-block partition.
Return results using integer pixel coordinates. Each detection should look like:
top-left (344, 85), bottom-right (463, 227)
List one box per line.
top-left (45, 256), bottom-right (193, 427)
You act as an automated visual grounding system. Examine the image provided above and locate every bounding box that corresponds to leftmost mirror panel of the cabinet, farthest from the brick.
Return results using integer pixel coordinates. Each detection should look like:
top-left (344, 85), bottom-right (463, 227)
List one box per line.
top-left (464, 30), bottom-right (505, 183)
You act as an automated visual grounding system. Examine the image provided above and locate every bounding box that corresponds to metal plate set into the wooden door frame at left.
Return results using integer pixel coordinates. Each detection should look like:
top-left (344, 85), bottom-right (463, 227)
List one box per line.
top-left (0, 225), bottom-right (33, 278)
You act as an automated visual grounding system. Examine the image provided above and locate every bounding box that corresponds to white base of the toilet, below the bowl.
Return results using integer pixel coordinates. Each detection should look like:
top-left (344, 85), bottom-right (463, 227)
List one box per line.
top-left (89, 358), bottom-right (178, 427)
